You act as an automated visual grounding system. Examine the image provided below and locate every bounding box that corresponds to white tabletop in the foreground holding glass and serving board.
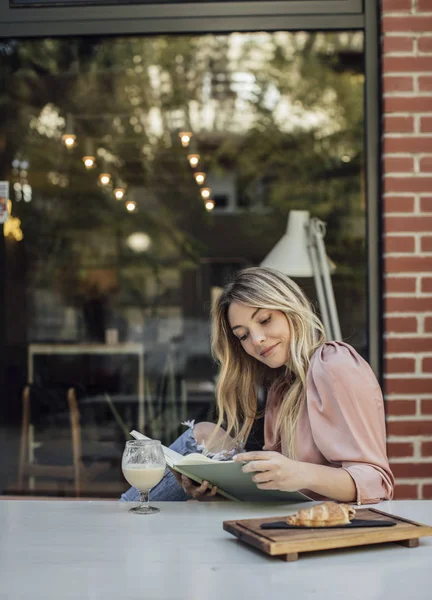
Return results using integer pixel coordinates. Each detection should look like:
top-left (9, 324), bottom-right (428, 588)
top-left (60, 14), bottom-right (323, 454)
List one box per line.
top-left (0, 500), bottom-right (432, 600)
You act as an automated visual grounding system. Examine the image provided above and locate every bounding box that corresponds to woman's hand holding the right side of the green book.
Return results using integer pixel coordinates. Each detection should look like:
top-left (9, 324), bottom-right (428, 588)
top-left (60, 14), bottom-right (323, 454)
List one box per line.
top-left (234, 451), bottom-right (307, 492)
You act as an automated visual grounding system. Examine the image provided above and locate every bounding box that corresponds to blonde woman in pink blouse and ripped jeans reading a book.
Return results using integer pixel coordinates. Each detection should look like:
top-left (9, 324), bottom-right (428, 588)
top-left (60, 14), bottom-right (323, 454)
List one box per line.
top-left (120, 267), bottom-right (394, 504)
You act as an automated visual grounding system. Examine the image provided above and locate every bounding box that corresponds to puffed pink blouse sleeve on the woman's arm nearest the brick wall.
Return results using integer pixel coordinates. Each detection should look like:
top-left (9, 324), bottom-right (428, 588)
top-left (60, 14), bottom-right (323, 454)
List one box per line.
top-left (307, 342), bottom-right (394, 504)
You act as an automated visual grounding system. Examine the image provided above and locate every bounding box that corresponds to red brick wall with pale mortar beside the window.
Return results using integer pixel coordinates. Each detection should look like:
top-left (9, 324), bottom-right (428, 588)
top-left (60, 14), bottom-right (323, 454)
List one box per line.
top-left (381, 0), bottom-right (432, 499)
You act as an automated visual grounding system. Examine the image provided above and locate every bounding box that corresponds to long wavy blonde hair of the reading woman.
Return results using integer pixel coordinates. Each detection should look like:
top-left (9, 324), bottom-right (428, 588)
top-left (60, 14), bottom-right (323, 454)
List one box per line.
top-left (212, 267), bottom-right (325, 458)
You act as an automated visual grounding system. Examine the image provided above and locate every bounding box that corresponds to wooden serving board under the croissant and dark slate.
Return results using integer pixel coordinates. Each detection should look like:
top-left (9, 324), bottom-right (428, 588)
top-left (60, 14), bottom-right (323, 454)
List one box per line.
top-left (223, 508), bottom-right (432, 562)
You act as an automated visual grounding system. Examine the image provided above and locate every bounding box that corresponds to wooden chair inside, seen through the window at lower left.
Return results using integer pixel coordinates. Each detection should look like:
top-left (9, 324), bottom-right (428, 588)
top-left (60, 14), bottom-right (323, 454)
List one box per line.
top-left (18, 385), bottom-right (110, 497)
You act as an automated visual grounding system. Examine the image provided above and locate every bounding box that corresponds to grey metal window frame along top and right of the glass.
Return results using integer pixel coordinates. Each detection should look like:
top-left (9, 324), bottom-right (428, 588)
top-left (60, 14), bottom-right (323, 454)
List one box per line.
top-left (0, 0), bottom-right (383, 380)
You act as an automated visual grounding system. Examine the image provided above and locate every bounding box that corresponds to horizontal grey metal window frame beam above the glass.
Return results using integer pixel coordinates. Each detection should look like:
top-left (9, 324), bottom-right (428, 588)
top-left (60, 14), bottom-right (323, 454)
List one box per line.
top-left (0, 0), bottom-right (363, 37)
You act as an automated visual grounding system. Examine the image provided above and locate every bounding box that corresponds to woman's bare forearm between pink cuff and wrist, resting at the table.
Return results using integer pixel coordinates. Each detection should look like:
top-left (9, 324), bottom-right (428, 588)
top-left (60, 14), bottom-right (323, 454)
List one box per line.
top-left (302, 463), bottom-right (357, 502)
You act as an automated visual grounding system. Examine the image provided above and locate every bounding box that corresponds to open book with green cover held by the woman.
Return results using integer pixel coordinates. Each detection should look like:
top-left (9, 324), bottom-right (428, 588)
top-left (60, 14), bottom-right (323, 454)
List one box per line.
top-left (130, 431), bottom-right (311, 504)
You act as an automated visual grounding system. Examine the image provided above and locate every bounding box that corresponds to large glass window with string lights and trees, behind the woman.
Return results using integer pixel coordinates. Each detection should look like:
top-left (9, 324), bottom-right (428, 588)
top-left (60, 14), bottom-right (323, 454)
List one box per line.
top-left (0, 32), bottom-right (368, 497)
